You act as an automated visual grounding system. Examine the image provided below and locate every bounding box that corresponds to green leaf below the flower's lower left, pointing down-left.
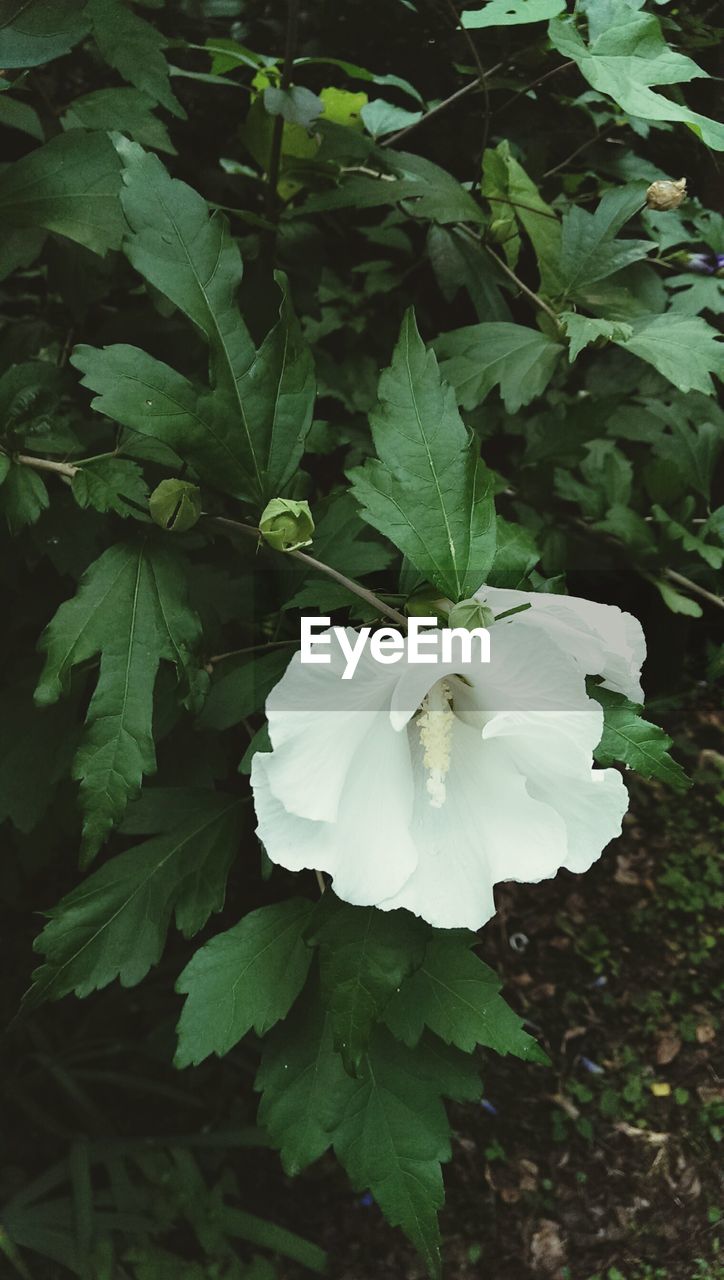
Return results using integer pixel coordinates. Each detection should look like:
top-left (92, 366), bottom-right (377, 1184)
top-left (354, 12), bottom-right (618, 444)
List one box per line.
top-left (174, 899), bottom-right (312, 1068)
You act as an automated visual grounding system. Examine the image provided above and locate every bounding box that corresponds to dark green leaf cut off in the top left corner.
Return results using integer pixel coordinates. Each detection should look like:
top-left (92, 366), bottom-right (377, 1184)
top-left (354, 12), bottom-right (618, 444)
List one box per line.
top-left (0, 0), bottom-right (88, 70)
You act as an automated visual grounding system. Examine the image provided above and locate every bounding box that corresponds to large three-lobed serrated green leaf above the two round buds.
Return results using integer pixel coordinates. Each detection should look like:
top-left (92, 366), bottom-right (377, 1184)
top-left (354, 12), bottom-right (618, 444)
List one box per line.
top-left (72, 142), bottom-right (315, 504)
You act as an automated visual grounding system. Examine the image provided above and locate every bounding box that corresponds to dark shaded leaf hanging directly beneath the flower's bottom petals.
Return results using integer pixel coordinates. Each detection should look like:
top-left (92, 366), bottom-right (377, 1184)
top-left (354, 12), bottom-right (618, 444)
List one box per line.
top-left (310, 892), bottom-right (430, 1075)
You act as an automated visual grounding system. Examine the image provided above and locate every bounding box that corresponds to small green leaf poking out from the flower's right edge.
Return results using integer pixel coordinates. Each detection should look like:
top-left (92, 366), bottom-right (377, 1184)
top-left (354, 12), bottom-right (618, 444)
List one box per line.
top-left (588, 685), bottom-right (691, 791)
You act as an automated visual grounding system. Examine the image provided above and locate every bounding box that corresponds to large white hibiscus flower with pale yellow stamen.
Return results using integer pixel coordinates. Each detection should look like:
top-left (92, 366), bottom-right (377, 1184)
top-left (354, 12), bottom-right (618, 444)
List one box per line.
top-left (252, 588), bottom-right (645, 929)
